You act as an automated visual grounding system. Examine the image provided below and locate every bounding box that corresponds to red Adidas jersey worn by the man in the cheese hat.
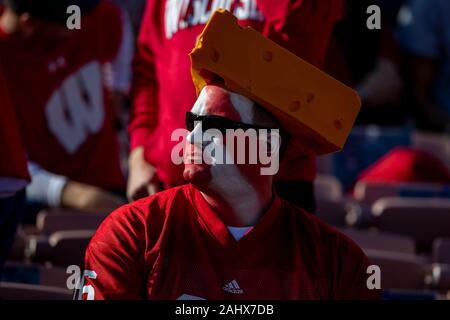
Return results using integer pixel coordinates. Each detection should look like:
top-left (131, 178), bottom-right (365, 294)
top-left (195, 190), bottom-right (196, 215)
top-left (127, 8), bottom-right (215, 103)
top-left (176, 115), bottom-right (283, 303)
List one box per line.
top-left (83, 184), bottom-right (379, 300)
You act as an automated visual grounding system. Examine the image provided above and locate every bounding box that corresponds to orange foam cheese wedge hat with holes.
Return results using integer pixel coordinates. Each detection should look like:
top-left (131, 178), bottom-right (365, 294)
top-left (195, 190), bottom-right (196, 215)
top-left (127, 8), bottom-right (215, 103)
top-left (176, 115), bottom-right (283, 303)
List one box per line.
top-left (190, 9), bottom-right (361, 154)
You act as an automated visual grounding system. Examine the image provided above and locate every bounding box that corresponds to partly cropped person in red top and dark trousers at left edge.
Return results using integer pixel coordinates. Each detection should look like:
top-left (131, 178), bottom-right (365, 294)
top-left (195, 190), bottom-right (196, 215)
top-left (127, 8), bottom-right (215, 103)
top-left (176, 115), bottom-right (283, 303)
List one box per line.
top-left (0, 62), bottom-right (30, 278)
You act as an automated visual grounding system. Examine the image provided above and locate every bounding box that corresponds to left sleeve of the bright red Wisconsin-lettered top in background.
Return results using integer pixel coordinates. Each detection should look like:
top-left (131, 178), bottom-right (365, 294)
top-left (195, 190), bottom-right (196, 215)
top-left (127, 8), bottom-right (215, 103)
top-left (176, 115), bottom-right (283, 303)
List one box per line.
top-left (128, 2), bottom-right (158, 149)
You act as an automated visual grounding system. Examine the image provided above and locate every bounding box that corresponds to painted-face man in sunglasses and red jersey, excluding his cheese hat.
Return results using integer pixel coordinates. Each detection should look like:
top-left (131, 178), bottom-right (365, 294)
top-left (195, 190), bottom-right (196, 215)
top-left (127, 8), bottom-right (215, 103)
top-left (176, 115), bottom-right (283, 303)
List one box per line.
top-left (80, 78), bottom-right (379, 300)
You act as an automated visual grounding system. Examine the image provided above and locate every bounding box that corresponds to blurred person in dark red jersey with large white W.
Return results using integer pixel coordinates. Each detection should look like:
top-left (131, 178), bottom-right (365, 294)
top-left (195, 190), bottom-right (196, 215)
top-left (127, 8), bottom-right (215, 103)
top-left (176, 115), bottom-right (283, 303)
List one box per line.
top-left (0, 0), bottom-right (132, 215)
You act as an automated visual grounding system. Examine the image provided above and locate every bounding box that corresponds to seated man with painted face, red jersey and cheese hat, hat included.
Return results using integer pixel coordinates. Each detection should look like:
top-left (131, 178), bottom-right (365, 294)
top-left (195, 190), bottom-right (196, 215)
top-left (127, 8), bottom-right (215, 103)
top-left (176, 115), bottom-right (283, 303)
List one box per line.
top-left (79, 10), bottom-right (379, 300)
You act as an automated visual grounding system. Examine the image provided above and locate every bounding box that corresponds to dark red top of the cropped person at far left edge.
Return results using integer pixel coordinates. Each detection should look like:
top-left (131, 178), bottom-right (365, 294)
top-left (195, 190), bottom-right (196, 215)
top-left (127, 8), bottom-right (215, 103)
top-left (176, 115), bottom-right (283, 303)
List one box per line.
top-left (0, 62), bottom-right (30, 180)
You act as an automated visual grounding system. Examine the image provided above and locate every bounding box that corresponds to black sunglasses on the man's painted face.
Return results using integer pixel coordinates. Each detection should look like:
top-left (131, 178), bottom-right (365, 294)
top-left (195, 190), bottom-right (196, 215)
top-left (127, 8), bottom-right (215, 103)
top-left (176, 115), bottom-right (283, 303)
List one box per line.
top-left (186, 111), bottom-right (278, 134)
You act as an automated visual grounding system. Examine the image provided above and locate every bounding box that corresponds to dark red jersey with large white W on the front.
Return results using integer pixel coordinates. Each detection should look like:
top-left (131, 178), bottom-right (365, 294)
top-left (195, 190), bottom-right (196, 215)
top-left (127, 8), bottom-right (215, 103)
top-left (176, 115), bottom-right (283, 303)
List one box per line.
top-left (0, 1), bottom-right (124, 189)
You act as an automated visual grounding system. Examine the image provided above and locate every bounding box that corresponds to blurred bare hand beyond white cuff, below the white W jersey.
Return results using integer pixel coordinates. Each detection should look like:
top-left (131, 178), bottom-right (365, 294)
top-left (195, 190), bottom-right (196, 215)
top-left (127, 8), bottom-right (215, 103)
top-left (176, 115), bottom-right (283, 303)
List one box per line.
top-left (61, 181), bottom-right (125, 213)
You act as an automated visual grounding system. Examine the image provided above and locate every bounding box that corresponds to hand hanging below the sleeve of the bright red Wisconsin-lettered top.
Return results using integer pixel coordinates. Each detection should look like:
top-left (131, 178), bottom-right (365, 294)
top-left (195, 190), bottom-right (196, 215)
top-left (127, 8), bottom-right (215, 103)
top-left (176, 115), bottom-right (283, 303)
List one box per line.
top-left (127, 147), bottom-right (161, 201)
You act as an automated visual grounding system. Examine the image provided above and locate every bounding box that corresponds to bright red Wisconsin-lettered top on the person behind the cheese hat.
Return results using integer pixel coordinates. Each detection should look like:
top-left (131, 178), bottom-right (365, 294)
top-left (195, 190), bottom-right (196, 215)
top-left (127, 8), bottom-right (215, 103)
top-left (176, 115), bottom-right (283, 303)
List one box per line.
top-left (129, 0), bottom-right (343, 187)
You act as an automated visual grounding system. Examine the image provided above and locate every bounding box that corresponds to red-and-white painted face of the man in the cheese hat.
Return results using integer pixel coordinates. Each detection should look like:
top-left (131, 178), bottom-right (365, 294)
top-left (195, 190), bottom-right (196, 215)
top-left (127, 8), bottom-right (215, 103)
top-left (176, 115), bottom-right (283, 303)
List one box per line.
top-left (183, 85), bottom-right (280, 192)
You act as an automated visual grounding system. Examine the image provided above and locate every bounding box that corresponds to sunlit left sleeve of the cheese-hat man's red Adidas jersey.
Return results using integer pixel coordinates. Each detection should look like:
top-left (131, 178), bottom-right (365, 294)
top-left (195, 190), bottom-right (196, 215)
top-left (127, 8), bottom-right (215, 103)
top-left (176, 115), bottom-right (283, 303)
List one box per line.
top-left (78, 205), bottom-right (146, 300)
